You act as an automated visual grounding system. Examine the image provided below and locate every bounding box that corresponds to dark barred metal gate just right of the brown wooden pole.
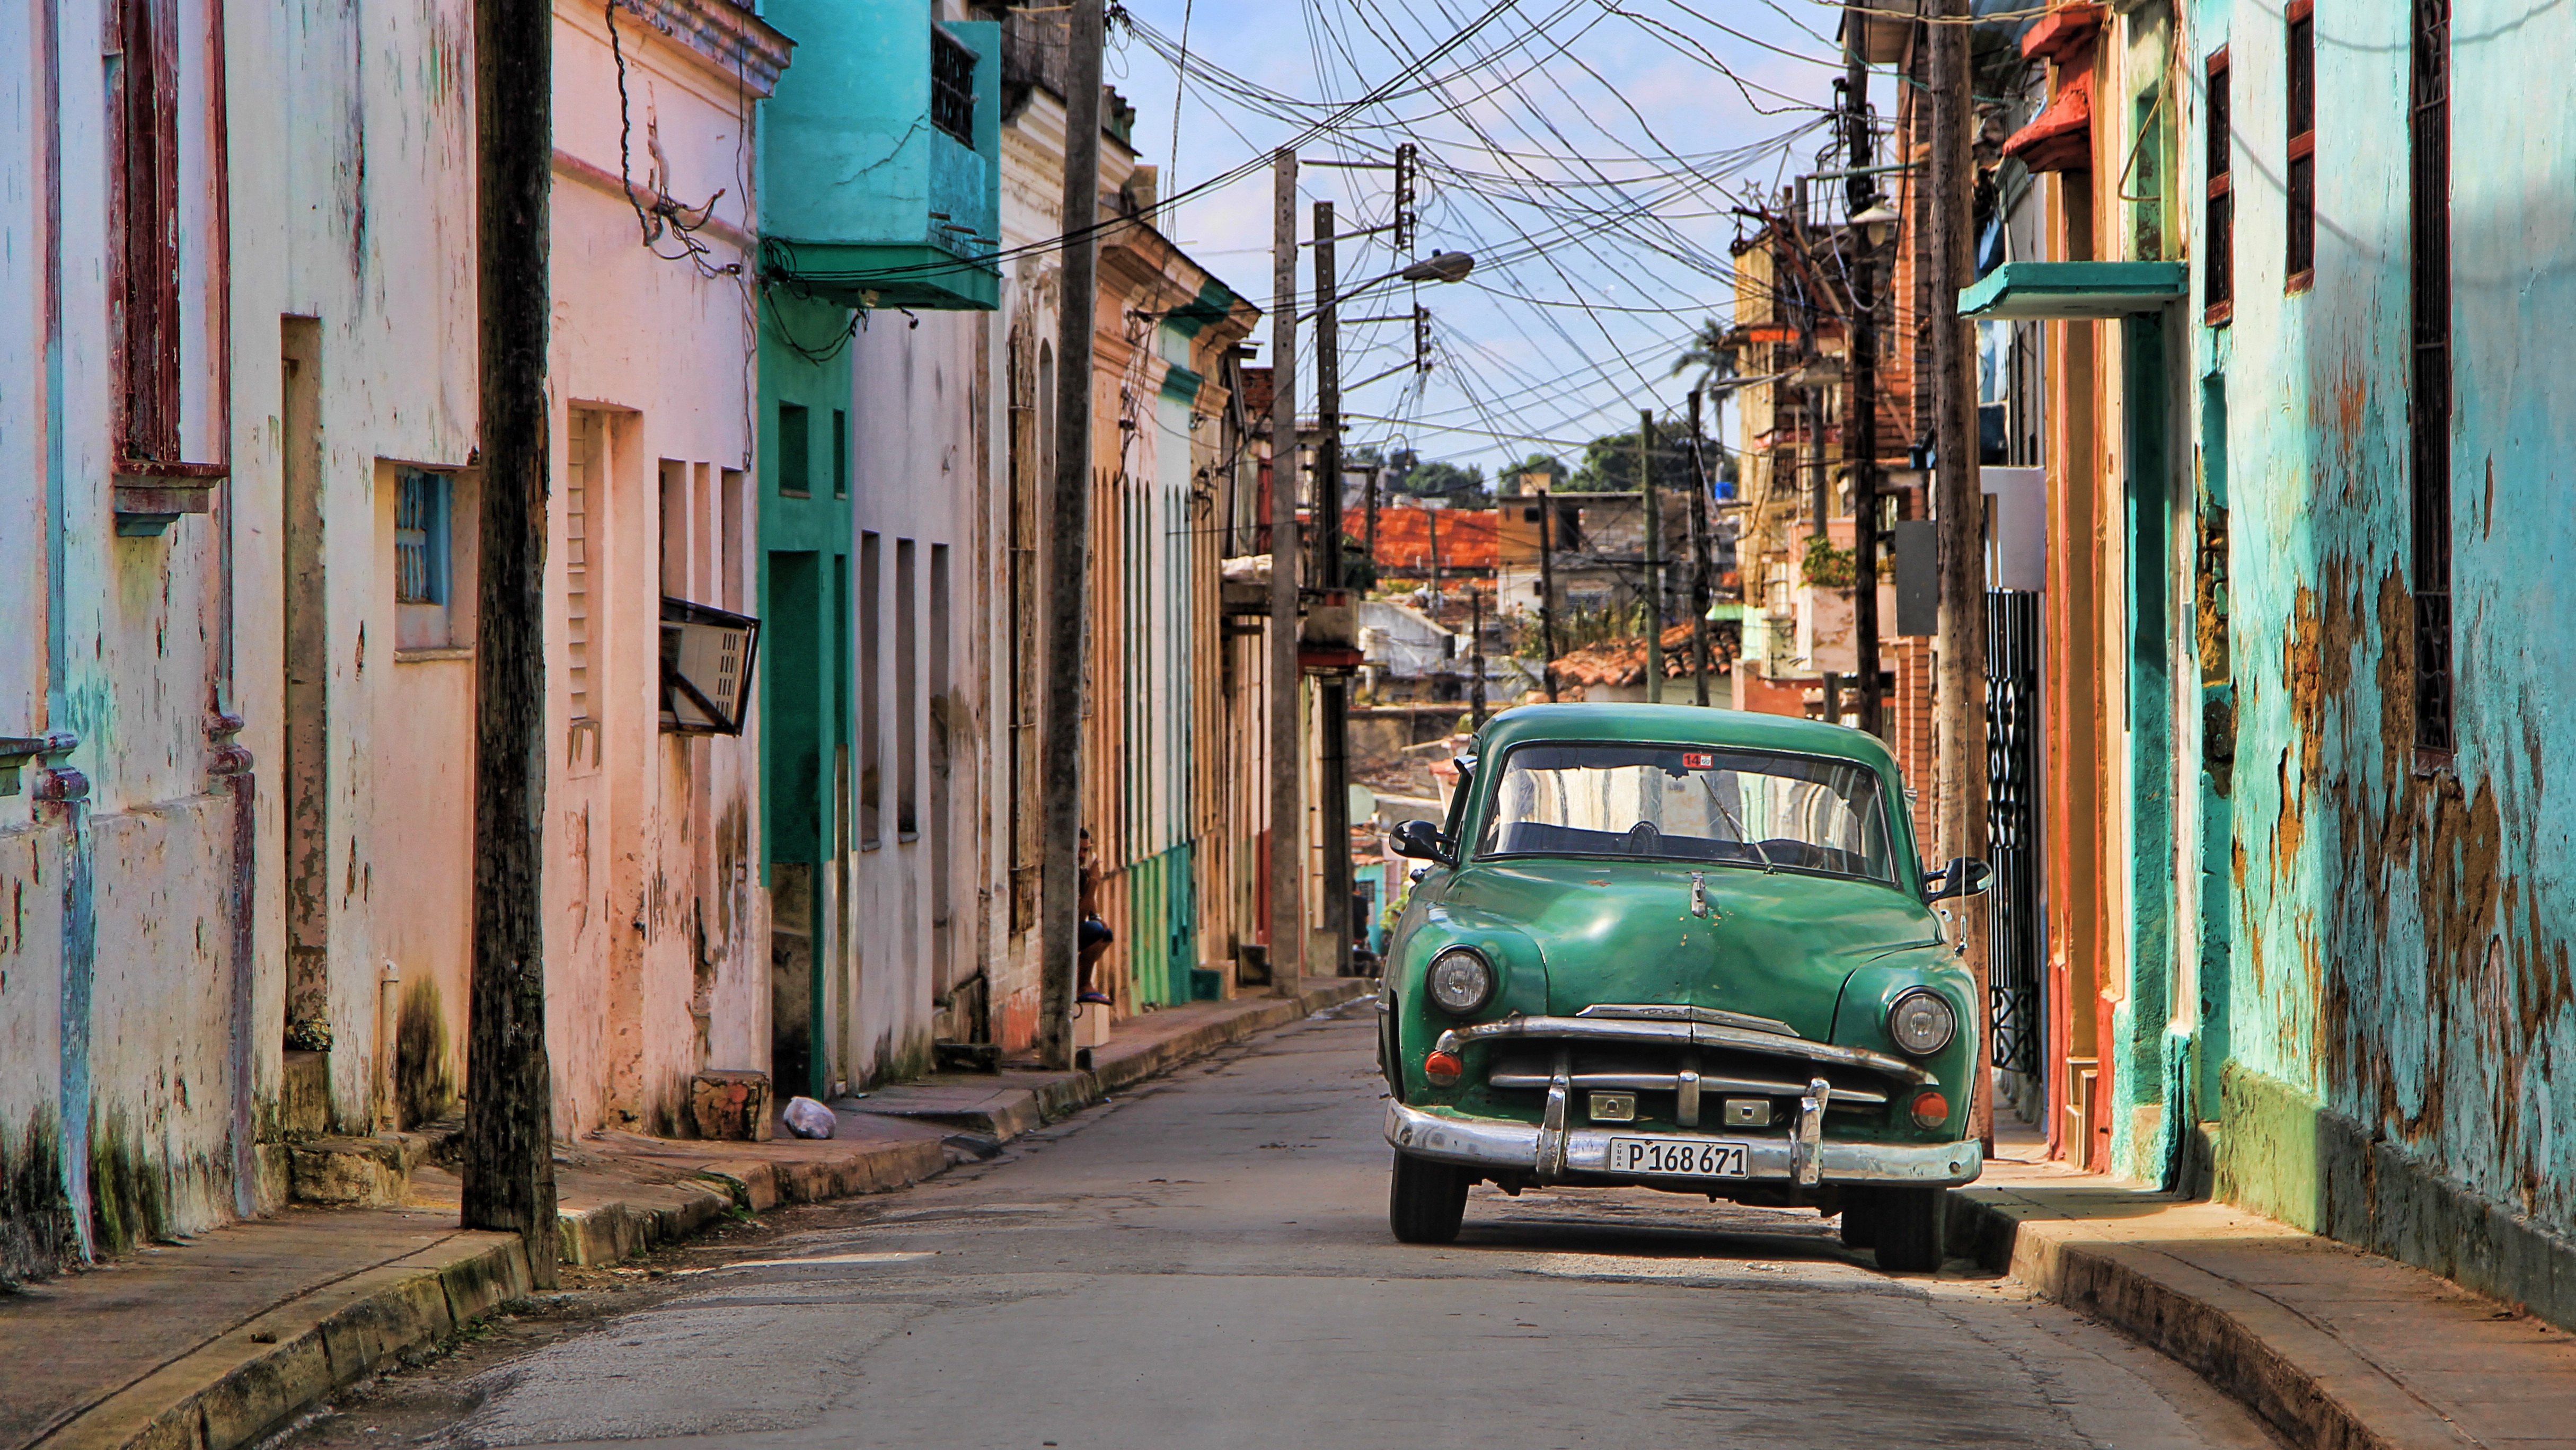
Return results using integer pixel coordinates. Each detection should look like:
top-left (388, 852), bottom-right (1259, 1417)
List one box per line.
top-left (1986, 590), bottom-right (2048, 1076)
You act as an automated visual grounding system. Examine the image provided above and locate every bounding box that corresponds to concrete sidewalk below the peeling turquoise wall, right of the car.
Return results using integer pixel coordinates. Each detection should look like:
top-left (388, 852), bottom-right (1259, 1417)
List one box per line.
top-left (1950, 1144), bottom-right (2576, 1450)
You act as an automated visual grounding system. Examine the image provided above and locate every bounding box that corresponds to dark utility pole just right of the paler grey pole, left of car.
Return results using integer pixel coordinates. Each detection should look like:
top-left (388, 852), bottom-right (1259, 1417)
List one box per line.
top-left (1314, 201), bottom-right (1350, 976)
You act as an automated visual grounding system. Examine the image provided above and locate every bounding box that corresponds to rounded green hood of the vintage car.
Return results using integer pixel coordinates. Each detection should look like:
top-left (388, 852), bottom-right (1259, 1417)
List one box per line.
top-left (1445, 857), bottom-right (1940, 1040)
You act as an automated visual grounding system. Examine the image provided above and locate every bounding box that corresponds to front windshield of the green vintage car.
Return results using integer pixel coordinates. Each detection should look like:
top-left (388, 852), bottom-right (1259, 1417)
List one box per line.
top-left (1476, 742), bottom-right (1896, 881)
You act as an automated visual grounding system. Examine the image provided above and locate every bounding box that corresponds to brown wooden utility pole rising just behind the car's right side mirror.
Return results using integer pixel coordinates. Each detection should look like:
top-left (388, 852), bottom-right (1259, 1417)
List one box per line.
top-left (1929, 0), bottom-right (1994, 1141)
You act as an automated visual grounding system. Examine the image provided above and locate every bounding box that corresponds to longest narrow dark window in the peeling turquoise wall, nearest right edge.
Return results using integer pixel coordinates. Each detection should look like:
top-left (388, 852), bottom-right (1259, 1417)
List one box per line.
top-left (2406, 0), bottom-right (2455, 755)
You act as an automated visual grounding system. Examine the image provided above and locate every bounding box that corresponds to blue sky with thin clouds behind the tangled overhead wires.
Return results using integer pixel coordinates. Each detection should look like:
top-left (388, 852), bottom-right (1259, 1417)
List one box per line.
top-left (1105, 0), bottom-right (1893, 476)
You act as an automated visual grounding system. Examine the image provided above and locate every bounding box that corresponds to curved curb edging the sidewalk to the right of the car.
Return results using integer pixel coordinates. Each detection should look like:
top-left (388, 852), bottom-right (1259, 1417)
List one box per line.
top-left (1947, 1187), bottom-right (2463, 1450)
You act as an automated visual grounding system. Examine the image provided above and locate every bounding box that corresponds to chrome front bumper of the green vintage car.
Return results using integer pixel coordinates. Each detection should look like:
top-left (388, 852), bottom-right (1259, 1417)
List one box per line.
top-left (1386, 1102), bottom-right (1986, 1187)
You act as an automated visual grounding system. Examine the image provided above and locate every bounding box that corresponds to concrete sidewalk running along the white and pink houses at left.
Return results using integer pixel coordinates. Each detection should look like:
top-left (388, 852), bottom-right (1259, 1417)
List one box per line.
top-left (0, 979), bottom-right (1375, 1450)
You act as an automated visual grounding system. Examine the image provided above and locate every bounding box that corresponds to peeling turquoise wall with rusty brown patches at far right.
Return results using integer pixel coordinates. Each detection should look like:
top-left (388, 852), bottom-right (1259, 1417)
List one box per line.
top-left (2184, 0), bottom-right (2576, 1283)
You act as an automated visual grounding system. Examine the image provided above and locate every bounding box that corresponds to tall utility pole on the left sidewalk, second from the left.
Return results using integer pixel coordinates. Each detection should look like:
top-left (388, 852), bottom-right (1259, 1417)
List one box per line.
top-left (1038, 0), bottom-right (1100, 1072)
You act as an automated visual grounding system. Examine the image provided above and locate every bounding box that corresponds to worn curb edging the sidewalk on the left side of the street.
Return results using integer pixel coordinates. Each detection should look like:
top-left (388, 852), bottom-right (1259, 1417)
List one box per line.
top-left (31, 979), bottom-right (1375, 1450)
